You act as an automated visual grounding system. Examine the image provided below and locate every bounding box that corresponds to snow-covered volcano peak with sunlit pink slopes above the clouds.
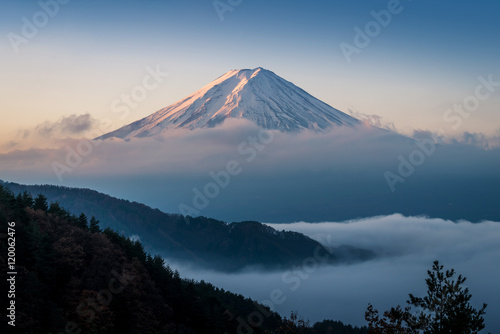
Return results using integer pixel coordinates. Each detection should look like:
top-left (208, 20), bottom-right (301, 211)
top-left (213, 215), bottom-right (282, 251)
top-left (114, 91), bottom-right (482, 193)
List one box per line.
top-left (98, 67), bottom-right (360, 139)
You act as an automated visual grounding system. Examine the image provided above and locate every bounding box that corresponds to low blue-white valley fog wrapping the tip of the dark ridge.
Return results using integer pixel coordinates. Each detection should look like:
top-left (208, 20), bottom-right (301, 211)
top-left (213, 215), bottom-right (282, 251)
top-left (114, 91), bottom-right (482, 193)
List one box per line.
top-left (167, 214), bottom-right (500, 333)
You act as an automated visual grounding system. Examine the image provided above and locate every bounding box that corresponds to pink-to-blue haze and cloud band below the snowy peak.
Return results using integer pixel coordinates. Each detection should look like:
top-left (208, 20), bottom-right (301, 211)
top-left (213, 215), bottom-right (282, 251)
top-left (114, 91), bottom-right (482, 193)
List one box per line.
top-left (0, 120), bottom-right (500, 222)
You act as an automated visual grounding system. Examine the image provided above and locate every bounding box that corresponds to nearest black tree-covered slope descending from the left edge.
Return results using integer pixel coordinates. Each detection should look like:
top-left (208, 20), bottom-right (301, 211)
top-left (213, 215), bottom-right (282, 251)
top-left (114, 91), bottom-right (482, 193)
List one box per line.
top-left (0, 186), bottom-right (366, 334)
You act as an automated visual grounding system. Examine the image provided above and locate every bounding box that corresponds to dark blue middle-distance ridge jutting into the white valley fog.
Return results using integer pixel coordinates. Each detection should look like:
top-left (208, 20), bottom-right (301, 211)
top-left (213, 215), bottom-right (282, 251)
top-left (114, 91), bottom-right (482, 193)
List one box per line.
top-left (0, 181), bottom-right (373, 271)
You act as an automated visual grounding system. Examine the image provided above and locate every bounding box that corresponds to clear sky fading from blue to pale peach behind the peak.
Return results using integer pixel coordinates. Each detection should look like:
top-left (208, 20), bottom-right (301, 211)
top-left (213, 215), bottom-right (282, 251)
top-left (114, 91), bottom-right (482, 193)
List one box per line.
top-left (0, 0), bottom-right (500, 145)
